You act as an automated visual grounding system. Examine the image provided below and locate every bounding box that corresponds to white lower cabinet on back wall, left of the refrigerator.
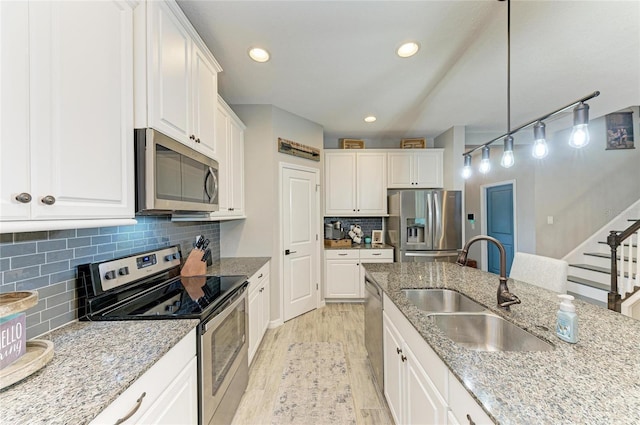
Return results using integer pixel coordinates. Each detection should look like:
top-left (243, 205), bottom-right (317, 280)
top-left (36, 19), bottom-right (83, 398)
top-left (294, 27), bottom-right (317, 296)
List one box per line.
top-left (324, 249), bottom-right (393, 299)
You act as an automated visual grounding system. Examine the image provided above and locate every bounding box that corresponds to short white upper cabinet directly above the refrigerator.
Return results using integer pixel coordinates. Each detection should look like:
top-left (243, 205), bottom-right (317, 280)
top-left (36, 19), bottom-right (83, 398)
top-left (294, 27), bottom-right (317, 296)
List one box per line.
top-left (387, 149), bottom-right (444, 189)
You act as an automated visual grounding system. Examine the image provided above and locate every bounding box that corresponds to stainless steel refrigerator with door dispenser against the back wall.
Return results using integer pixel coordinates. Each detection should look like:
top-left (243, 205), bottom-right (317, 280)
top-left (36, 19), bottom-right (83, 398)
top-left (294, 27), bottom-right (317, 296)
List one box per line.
top-left (385, 189), bottom-right (462, 262)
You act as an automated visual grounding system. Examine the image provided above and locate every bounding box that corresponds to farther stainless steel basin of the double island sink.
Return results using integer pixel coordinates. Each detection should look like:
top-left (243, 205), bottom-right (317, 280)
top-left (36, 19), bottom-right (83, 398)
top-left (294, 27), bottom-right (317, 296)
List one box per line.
top-left (402, 288), bottom-right (485, 313)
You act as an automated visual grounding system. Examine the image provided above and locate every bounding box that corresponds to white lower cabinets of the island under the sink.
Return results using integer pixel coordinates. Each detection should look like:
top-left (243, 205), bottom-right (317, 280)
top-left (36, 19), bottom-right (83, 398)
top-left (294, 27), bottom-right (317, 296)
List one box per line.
top-left (383, 295), bottom-right (493, 425)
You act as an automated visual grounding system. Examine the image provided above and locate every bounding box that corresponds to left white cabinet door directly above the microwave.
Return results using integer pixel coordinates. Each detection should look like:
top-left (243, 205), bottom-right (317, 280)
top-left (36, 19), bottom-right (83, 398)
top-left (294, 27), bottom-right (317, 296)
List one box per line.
top-left (146, 1), bottom-right (190, 145)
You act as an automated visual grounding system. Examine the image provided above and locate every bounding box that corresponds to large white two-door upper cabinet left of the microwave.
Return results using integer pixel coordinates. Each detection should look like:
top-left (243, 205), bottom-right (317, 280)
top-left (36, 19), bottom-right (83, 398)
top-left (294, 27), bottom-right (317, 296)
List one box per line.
top-left (0, 1), bottom-right (135, 227)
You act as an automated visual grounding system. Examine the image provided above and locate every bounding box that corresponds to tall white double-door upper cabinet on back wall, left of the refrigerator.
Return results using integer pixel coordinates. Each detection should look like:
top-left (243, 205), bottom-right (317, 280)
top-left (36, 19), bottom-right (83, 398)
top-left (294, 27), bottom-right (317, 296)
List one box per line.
top-left (324, 150), bottom-right (387, 216)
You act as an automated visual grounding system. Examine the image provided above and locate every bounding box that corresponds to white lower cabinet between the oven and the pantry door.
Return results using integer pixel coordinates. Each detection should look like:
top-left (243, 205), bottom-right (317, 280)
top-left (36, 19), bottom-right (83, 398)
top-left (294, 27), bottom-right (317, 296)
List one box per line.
top-left (249, 262), bottom-right (271, 364)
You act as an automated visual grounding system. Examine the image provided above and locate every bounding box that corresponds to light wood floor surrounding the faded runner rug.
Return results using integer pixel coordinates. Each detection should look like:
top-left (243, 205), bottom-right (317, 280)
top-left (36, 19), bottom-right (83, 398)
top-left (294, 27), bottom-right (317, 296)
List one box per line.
top-left (232, 304), bottom-right (393, 425)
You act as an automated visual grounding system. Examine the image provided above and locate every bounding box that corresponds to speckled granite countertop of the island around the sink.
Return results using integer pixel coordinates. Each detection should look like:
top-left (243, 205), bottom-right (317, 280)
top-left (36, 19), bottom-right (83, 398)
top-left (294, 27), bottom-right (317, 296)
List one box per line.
top-left (365, 263), bottom-right (640, 425)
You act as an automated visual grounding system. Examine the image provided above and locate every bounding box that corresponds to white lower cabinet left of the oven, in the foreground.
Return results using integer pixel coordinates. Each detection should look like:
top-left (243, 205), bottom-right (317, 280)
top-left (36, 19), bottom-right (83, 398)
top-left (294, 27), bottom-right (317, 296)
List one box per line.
top-left (91, 329), bottom-right (198, 424)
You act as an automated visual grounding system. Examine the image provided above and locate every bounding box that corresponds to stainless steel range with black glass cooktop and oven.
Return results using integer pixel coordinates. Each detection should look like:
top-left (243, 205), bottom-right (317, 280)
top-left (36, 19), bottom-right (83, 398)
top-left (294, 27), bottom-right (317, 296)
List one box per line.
top-left (78, 245), bottom-right (249, 425)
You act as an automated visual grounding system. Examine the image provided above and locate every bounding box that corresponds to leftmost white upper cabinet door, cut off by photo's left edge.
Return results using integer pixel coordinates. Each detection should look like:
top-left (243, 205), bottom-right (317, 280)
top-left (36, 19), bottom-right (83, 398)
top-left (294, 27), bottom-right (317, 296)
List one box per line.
top-left (0, 1), bottom-right (31, 220)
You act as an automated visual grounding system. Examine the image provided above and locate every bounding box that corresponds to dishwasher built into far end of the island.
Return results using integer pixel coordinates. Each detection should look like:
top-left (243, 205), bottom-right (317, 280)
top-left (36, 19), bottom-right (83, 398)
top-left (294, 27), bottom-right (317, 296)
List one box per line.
top-left (364, 271), bottom-right (384, 391)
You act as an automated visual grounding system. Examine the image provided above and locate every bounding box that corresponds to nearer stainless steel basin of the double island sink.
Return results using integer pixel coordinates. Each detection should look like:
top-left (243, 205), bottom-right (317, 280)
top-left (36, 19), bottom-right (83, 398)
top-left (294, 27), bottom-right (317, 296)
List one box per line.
top-left (431, 313), bottom-right (553, 351)
